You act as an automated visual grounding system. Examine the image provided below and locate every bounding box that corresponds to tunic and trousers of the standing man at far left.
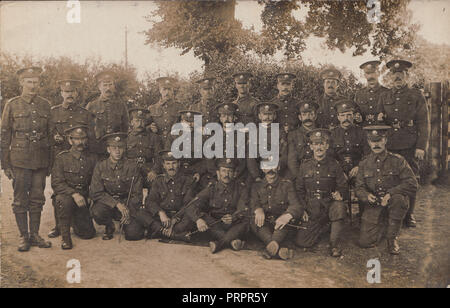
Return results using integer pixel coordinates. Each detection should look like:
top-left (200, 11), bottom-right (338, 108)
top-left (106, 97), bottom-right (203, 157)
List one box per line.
top-left (1, 96), bottom-right (50, 214)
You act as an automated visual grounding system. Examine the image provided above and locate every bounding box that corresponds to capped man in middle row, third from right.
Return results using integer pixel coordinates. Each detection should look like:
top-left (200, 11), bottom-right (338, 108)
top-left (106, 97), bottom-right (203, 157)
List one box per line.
top-left (247, 103), bottom-right (288, 182)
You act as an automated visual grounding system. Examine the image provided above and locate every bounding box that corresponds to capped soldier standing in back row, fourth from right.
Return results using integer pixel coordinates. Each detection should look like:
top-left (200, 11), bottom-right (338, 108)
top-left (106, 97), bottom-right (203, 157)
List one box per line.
top-left (271, 73), bottom-right (299, 134)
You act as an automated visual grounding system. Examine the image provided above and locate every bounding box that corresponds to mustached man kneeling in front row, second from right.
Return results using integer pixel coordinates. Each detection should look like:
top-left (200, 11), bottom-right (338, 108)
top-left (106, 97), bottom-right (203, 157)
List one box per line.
top-left (296, 129), bottom-right (348, 257)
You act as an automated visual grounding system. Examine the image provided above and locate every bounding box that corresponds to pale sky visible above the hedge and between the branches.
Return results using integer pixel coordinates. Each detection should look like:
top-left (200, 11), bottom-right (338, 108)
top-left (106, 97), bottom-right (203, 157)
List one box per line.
top-left (0, 0), bottom-right (450, 78)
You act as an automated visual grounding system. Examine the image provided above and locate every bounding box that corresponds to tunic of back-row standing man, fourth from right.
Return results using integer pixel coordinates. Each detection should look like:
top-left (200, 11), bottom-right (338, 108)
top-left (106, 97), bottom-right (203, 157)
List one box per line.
top-left (271, 95), bottom-right (300, 133)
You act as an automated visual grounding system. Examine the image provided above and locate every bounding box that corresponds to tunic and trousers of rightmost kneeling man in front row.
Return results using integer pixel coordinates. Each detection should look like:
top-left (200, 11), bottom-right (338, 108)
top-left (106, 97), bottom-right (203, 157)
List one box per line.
top-left (356, 152), bottom-right (418, 247)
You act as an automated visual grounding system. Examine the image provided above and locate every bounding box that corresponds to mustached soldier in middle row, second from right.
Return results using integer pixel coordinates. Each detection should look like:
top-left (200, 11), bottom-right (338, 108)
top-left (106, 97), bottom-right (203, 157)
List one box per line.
top-left (287, 102), bottom-right (319, 179)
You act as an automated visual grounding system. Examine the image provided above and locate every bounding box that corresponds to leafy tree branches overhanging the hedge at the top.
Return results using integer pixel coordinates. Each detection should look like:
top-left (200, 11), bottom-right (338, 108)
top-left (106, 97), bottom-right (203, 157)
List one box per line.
top-left (145, 0), bottom-right (418, 67)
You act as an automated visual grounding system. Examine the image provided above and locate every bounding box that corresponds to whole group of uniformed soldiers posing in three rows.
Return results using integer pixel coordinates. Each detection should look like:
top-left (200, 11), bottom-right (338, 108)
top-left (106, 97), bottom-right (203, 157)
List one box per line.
top-left (1, 60), bottom-right (429, 260)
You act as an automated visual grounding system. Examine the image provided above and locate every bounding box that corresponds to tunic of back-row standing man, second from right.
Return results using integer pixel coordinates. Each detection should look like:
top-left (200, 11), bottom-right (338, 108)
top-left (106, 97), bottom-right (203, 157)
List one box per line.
top-left (353, 85), bottom-right (389, 126)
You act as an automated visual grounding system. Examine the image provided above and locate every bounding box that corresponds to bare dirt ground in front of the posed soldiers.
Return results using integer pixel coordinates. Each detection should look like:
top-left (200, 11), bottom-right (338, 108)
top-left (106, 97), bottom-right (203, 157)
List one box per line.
top-left (0, 180), bottom-right (450, 288)
